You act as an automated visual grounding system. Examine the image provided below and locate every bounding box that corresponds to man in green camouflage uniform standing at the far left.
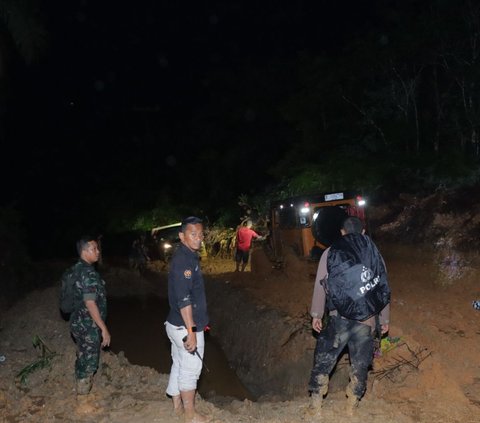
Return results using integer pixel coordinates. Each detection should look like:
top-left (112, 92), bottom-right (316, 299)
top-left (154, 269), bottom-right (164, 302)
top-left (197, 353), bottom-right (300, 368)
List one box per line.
top-left (70, 236), bottom-right (110, 395)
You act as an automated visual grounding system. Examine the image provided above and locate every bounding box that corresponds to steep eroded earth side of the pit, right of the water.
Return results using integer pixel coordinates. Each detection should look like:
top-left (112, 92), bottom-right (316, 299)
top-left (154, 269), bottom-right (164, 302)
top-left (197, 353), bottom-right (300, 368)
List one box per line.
top-left (207, 277), bottom-right (315, 398)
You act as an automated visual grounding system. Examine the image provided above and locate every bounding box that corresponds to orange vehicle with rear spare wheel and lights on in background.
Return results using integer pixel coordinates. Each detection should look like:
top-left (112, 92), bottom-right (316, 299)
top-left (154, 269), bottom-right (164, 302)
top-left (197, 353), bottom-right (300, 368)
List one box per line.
top-left (270, 192), bottom-right (366, 261)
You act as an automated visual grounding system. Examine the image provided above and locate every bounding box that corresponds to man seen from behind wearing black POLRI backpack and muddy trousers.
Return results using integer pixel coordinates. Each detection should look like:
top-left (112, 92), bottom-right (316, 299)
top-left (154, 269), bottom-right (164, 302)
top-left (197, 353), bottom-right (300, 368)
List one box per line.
top-left (309, 216), bottom-right (390, 413)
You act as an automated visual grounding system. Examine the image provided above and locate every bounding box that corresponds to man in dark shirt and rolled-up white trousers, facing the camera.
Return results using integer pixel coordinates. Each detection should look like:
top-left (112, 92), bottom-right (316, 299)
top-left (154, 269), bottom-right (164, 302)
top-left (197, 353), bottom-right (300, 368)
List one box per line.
top-left (165, 216), bottom-right (209, 423)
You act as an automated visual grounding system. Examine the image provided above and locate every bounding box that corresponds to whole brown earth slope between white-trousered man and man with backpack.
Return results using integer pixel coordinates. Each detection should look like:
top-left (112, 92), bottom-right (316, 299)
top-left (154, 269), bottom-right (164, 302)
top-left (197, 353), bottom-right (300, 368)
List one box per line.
top-left (204, 246), bottom-right (368, 401)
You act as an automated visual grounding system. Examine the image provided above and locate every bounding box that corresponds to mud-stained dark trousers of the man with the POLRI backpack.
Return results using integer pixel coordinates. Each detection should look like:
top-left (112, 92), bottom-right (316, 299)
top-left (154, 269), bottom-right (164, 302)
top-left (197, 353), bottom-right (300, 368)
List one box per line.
top-left (308, 316), bottom-right (373, 398)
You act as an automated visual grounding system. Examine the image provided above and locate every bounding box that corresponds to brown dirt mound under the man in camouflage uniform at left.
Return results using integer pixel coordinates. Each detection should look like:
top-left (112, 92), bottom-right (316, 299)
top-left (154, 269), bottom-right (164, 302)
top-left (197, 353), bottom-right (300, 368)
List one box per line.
top-left (0, 288), bottom-right (213, 422)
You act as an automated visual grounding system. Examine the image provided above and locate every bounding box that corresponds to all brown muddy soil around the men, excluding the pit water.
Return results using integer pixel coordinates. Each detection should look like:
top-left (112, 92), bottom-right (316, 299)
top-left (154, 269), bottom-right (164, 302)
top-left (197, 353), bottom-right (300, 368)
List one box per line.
top-left (0, 190), bottom-right (480, 423)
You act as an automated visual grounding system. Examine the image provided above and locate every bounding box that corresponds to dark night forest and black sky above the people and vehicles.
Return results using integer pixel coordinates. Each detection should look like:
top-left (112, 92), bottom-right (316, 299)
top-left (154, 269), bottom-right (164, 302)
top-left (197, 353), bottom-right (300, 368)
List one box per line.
top-left (0, 0), bottom-right (480, 255)
